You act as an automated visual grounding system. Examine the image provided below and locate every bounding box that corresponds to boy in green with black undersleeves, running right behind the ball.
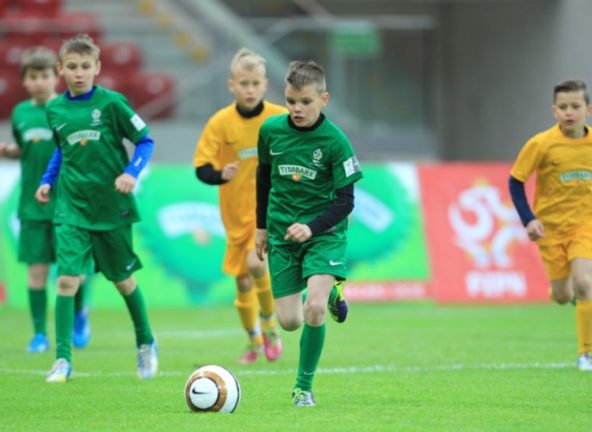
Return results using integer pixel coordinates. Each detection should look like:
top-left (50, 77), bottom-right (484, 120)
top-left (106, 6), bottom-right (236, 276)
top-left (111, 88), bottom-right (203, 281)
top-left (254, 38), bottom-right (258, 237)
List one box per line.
top-left (255, 61), bottom-right (362, 406)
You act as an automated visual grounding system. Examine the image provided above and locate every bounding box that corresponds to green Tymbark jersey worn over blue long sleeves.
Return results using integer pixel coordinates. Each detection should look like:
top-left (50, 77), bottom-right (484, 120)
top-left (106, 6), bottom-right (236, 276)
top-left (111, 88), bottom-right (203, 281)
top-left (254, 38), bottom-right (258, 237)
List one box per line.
top-left (47, 86), bottom-right (148, 230)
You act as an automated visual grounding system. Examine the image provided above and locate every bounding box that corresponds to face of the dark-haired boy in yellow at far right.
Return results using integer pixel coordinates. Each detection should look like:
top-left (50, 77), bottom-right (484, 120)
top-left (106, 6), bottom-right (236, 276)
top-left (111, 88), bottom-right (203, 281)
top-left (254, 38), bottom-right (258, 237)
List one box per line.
top-left (553, 90), bottom-right (592, 136)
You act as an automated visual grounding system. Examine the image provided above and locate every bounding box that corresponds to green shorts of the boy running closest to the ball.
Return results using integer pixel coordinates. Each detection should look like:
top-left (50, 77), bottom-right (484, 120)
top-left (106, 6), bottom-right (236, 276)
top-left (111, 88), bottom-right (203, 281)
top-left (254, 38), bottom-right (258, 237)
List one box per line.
top-left (268, 233), bottom-right (347, 298)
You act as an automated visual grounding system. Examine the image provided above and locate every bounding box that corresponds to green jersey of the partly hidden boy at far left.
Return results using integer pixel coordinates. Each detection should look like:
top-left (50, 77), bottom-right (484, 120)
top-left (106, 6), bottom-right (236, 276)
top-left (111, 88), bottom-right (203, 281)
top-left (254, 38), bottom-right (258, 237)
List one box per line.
top-left (12, 99), bottom-right (56, 221)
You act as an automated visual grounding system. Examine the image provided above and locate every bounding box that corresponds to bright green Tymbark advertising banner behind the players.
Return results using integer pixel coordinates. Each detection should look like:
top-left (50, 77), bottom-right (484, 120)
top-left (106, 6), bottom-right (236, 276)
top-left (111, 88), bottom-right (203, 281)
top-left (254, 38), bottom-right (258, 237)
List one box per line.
top-left (0, 164), bottom-right (429, 307)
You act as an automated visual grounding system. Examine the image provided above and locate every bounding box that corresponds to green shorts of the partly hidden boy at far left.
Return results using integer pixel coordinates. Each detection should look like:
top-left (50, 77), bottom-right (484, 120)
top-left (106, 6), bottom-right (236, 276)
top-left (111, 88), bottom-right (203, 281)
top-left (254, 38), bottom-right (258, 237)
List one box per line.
top-left (18, 220), bottom-right (56, 264)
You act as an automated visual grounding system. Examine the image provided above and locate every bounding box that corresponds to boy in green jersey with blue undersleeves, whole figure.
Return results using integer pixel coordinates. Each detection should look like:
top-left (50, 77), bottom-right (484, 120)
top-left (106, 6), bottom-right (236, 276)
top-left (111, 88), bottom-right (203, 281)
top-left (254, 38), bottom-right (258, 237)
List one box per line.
top-left (35, 35), bottom-right (158, 383)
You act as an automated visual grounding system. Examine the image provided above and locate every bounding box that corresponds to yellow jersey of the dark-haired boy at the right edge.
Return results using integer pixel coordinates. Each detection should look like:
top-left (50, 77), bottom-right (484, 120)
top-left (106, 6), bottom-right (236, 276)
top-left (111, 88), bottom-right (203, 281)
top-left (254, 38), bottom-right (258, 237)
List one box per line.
top-left (511, 125), bottom-right (592, 241)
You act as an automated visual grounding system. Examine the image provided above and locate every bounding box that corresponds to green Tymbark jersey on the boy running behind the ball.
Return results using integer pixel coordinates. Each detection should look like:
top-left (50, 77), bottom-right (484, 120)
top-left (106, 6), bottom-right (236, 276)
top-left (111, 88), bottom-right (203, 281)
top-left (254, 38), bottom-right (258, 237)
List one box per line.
top-left (257, 115), bottom-right (362, 242)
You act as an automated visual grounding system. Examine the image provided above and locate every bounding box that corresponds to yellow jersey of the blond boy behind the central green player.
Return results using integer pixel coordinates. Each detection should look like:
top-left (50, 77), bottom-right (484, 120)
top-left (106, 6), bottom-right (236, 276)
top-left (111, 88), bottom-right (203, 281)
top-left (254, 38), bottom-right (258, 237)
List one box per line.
top-left (193, 101), bottom-right (287, 244)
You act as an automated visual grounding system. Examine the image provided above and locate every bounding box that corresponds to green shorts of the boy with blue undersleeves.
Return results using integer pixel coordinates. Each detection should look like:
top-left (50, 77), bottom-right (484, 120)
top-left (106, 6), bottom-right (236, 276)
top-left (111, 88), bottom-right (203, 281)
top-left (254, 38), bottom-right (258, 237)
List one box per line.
top-left (56, 225), bottom-right (142, 282)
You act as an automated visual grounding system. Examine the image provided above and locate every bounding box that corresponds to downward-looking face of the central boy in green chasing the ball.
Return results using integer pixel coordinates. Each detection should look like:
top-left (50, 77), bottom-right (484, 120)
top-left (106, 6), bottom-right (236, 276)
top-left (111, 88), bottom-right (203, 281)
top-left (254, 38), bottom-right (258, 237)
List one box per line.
top-left (284, 84), bottom-right (329, 127)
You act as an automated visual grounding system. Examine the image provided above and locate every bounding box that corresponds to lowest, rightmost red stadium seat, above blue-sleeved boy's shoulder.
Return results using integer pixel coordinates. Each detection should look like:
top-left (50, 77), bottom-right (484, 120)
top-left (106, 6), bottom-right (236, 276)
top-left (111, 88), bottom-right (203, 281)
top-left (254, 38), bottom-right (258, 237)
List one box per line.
top-left (131, 73), bottom-right (176, 119)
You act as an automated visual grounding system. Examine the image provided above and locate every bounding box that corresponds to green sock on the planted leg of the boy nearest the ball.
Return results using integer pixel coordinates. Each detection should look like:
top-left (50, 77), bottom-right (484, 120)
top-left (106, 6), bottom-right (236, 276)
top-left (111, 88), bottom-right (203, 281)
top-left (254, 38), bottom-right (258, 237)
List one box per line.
top-left (296, 323), bottom-right (326, 391)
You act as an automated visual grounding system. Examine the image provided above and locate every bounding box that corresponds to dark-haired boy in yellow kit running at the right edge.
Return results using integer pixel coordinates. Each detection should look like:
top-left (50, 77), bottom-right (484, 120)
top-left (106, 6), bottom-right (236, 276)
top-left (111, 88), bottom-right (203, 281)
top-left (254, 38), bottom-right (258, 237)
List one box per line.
top-left (510, 80), bottom-right (592, 371)
